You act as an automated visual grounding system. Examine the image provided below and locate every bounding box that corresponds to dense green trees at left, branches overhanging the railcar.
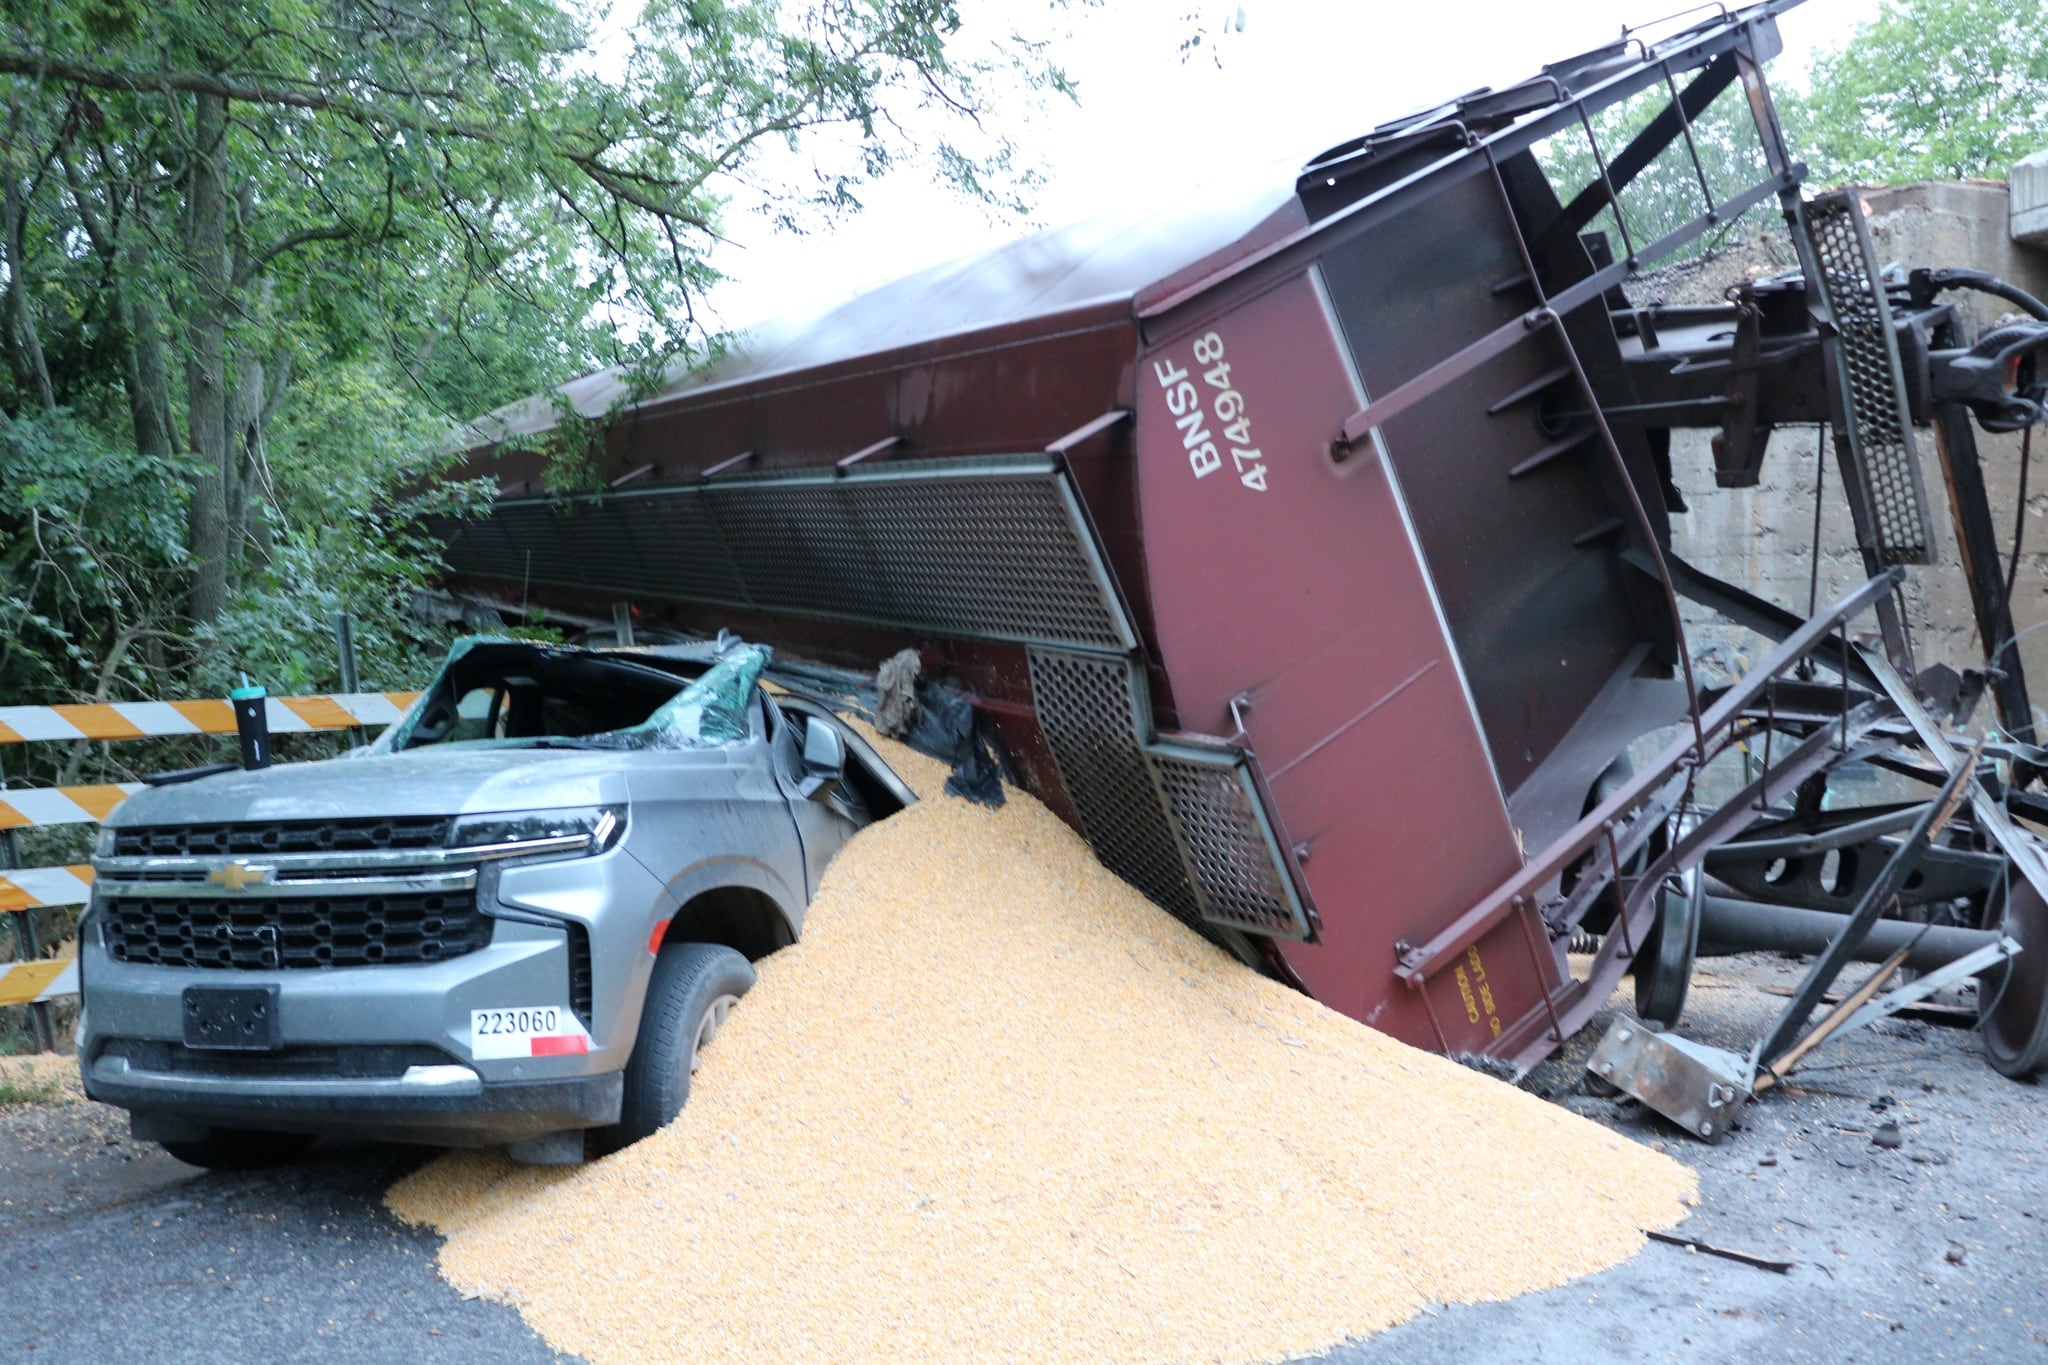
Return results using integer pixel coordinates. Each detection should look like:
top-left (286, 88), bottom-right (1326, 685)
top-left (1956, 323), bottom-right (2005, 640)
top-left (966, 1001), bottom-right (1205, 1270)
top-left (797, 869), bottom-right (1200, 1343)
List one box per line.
top-left (0, 0), bottom-right (1069, 700)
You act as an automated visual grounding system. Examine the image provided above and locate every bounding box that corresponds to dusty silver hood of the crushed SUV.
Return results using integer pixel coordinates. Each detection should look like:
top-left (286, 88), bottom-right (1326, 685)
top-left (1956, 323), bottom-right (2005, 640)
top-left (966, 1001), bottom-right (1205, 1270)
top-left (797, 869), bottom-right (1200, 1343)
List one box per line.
top-left (106, 747), bottom-right (733, 829)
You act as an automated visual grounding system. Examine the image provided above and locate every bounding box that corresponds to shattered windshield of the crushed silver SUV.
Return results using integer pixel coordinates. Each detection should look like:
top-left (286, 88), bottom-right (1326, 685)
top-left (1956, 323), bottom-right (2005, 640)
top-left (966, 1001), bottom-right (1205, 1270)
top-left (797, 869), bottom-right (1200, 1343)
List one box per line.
top-left (373, 641), bottom-right (770, 753)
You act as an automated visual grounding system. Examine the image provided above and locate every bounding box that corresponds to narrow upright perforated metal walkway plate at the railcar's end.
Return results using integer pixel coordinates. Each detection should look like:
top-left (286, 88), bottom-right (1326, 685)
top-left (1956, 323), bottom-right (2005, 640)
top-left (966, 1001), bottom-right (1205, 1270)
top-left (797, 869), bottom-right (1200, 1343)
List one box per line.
top-left (1804, 190), bottom-right (1933, 565)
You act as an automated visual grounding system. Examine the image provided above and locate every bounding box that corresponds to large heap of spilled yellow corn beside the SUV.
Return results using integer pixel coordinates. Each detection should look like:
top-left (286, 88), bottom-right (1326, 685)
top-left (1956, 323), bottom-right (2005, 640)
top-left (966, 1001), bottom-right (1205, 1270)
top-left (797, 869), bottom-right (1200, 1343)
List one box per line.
top-left (389, 745), bottom-right (1694, 1363)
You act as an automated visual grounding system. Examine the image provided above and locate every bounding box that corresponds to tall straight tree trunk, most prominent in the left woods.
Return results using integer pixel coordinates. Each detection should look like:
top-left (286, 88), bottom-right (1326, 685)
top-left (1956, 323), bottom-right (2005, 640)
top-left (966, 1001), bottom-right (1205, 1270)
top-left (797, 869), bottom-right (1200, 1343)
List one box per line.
top-left (184, 94), bottom-right (238, 624)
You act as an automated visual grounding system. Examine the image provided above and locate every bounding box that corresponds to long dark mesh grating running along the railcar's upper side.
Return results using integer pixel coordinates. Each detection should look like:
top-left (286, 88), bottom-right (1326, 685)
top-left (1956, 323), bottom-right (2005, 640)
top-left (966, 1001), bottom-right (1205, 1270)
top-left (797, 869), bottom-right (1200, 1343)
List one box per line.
top-left (430, 456), bottom-right (1137, 653)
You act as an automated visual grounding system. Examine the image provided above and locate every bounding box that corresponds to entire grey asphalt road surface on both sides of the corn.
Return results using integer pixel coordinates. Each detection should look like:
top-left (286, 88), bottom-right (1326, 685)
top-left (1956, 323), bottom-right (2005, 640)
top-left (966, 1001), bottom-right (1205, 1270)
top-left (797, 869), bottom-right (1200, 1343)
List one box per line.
top-left (0, 958), bottom-right (2048, 1365)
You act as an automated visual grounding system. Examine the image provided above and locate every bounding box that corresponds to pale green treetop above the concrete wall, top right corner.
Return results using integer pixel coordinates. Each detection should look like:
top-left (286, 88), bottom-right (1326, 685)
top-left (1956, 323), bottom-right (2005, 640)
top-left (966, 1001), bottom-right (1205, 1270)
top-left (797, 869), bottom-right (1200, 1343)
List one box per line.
top-left (1780, 0), bottom-right (2048, 184)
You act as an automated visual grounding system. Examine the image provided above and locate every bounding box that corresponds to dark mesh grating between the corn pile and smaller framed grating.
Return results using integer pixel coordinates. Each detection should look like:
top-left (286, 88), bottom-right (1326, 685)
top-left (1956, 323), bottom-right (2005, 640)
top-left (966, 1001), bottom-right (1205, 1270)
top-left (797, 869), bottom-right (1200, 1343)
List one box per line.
top-left (1030, 649), bottom-right (1202, 929)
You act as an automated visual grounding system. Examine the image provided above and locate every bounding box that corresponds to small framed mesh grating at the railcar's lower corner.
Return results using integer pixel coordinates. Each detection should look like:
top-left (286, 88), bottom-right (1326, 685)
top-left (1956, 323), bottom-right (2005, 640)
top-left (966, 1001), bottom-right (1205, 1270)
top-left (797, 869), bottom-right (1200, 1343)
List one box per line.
top-left (1145, 745), bottom-right (1309, 939)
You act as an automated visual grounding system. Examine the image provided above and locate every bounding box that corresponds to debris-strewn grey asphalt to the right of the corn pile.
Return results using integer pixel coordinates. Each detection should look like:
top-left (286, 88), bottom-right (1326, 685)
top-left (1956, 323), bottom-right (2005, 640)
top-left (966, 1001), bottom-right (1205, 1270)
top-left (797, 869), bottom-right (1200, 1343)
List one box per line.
top-left (1319, 956), bottom-right (2048, 1365)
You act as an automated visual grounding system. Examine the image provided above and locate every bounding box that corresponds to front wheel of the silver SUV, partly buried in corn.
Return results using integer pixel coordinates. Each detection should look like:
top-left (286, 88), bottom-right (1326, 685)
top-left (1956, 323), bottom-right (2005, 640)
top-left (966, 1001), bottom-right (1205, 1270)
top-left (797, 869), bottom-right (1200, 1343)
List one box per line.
top-left (590, 943), bottom-right (754, 1152)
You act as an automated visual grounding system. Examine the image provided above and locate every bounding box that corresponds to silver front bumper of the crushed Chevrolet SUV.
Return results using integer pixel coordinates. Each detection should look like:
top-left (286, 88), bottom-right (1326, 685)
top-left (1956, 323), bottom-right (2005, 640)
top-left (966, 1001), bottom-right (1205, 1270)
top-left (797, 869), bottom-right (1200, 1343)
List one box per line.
top-left (78, 851), bottom-right (659, 1146)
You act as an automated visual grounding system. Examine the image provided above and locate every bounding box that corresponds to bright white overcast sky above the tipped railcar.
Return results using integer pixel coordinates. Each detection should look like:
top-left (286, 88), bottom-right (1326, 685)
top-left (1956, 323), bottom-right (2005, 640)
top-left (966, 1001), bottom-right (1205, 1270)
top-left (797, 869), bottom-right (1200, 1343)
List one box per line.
top-left (711, 0), bottom-right (1878, 327)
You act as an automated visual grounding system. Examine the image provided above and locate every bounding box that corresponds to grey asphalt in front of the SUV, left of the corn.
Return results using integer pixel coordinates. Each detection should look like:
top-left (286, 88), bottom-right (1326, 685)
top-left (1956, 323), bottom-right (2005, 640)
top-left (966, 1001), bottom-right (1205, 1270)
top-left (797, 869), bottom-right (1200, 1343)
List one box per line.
top-left (0, 1101), bottom-right (565, 1363)
